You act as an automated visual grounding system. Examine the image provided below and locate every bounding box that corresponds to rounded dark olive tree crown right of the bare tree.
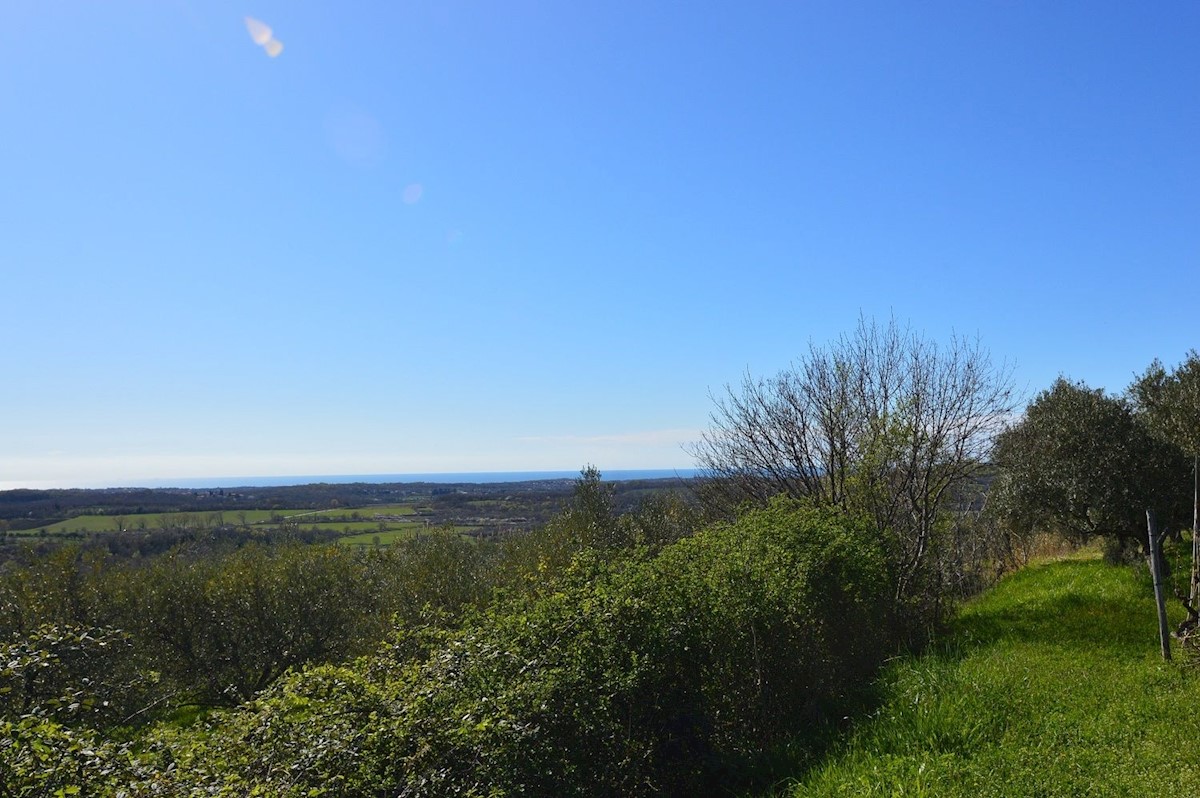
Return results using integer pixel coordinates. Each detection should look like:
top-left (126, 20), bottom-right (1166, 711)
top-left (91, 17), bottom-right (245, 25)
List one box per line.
top-left (990, 378), bottom-right (1187, 548)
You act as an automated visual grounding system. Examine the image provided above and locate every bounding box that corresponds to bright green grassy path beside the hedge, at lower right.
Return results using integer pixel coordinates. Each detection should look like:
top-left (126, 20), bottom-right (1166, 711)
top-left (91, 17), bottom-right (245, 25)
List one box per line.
top-left (779, 560), bottom-right (1200, 798)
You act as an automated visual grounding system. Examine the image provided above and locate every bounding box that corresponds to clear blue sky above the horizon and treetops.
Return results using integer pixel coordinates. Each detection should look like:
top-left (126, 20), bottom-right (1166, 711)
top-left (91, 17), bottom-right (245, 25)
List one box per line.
top-left (0, 0), bottom-right (1200, 487)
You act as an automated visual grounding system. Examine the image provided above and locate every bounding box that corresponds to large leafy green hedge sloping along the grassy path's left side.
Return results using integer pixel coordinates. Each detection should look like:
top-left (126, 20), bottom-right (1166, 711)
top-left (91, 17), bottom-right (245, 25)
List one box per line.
top-left (131, 502), bottom-right (892, 796)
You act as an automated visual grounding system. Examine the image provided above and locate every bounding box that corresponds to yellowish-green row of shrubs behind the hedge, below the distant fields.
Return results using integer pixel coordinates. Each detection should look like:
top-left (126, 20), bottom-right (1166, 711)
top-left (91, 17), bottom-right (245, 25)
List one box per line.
top-left (0, 533), bottom-right (492, 712)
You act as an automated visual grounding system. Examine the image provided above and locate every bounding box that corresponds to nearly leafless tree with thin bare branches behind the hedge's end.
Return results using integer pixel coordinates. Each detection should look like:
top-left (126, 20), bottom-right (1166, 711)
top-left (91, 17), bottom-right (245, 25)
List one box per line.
top-left (692, 319), bottom-right (1014, 596)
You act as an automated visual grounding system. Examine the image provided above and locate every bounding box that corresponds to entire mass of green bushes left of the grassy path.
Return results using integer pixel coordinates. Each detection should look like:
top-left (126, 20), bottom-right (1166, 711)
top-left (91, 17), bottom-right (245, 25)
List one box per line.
top-left (0, 475), bottom-right (905, 797)
